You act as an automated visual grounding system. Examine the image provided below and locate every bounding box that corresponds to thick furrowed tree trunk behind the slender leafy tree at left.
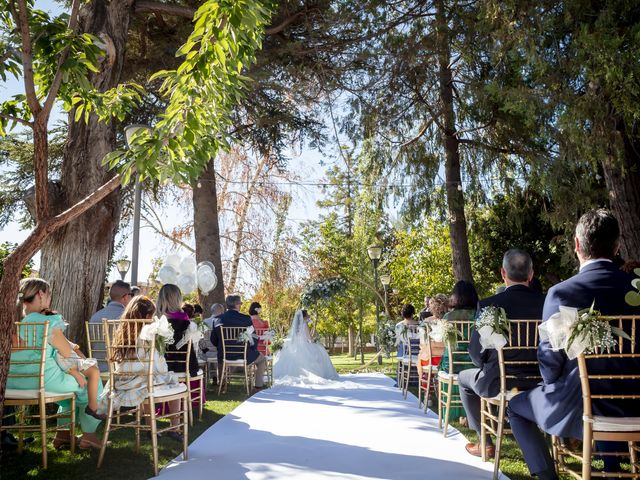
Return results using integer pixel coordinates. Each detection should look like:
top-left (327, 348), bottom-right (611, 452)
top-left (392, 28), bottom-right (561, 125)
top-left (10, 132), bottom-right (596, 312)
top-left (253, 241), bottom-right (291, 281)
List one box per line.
top-left (41, 0), bottom-right (133, 345)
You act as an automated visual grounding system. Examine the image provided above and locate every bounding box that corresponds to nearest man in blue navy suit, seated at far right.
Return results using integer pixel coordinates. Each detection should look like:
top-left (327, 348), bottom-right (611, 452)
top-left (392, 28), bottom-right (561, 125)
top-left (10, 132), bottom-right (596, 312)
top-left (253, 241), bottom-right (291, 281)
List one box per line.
top-left (507, 209), bottom-right (640, 480)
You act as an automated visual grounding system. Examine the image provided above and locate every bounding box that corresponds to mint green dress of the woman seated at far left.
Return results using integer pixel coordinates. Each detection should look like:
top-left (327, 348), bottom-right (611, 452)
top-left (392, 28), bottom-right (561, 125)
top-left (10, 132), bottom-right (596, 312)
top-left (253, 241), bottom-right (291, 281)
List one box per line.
top-left (7, 313), bottom-right (102, 433)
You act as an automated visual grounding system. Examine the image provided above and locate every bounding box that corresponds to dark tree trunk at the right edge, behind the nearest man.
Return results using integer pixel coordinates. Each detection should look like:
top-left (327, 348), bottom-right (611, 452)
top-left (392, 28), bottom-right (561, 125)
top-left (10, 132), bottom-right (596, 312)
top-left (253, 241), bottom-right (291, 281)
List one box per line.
top-left (602, 122), bottom-right (640, 260)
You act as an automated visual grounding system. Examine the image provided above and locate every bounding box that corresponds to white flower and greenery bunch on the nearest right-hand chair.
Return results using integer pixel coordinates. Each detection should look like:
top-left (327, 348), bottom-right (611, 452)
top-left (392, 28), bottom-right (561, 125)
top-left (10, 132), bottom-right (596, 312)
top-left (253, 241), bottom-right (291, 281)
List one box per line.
top-left (538, 303), bottom-right (629, 359)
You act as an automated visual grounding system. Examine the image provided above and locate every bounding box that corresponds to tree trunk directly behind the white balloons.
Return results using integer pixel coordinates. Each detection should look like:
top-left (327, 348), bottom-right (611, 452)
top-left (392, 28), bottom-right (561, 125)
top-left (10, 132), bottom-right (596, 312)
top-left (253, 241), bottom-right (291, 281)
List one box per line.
top-left (193, 160), bottom-right (224, 316)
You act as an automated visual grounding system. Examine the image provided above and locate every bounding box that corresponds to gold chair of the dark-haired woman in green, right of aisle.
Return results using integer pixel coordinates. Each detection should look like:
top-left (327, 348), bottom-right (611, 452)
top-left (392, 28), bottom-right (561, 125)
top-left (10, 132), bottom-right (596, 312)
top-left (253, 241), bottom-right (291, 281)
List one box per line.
top-left (438, 320), bottom-right (475, 437)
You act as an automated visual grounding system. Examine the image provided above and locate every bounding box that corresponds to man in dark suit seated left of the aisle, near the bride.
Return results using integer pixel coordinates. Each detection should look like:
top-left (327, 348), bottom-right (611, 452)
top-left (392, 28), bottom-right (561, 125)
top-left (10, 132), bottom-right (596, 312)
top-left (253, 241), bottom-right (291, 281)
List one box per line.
top-left (211, 295), bottom-right (267, 390)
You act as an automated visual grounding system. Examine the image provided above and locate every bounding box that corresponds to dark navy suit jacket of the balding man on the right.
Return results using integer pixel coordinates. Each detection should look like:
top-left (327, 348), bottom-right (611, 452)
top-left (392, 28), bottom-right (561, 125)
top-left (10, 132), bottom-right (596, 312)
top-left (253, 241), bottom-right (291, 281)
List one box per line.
top-left (469, 285), bottom-right (544, 397)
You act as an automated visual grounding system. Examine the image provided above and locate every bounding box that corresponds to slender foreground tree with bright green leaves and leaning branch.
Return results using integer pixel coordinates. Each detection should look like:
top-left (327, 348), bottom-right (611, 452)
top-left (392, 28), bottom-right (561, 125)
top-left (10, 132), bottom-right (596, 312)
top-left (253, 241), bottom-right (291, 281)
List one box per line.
top-left (0, 0), bottom-right (270, 408)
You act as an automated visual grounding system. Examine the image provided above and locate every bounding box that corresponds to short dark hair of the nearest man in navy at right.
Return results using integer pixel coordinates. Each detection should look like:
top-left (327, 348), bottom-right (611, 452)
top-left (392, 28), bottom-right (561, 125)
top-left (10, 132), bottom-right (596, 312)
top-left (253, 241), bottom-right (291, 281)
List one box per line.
top-left (576, 208), bottom-right (620, 259)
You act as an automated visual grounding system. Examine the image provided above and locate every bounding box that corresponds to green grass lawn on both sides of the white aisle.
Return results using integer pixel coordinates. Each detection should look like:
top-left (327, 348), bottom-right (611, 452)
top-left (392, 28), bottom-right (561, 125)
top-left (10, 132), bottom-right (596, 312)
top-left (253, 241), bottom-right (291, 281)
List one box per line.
top-left (0, 354), bottom-right (576, 480)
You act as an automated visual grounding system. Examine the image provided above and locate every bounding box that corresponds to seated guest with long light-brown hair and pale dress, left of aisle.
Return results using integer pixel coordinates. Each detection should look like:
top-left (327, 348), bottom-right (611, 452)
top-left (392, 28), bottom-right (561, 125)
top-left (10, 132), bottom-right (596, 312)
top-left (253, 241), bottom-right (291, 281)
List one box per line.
top-left (100, 296), bottom-right (182, 442)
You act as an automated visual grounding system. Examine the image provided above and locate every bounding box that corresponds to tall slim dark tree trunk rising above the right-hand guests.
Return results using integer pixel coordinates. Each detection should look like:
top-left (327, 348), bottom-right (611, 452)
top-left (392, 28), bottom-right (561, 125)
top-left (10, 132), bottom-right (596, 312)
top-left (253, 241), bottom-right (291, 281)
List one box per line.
top-left (436, 0), bottom-right (473, 282)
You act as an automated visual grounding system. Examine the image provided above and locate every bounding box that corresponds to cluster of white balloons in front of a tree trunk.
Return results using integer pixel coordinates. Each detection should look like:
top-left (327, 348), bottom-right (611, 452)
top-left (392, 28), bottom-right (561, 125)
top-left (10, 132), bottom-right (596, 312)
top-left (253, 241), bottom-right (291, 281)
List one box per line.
top-left (158, 253), bottom-right (218, 295)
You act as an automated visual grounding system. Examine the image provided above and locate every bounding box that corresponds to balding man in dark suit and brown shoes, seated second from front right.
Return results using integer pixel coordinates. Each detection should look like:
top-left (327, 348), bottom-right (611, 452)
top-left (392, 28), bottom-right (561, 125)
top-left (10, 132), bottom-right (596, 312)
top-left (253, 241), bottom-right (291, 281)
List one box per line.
top-left (458, 248), bottom-right (544, 458)
